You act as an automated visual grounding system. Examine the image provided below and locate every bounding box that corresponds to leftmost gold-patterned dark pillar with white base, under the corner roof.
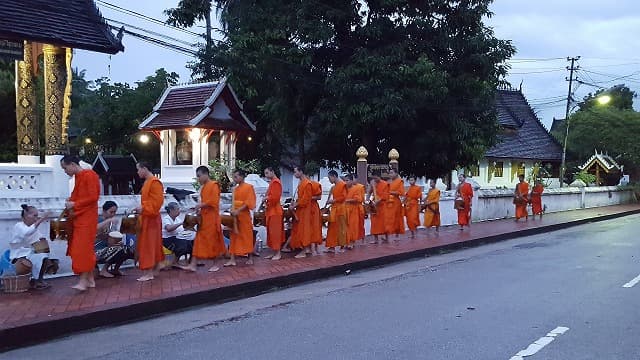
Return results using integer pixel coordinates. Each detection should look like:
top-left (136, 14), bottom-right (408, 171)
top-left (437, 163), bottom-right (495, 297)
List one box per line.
top-left (16, 41), bottom-right (40, 164)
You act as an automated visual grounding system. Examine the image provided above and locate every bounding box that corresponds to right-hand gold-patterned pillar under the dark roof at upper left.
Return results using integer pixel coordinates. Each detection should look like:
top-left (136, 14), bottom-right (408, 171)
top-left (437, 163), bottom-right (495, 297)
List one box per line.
top-left (43, 45), bottom-right (67, 155)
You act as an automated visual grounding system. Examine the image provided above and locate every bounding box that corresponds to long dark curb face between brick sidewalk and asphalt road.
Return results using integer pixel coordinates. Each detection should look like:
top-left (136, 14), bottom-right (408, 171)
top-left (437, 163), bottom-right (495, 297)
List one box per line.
top-left (0, 209), bottom-right (640, 351)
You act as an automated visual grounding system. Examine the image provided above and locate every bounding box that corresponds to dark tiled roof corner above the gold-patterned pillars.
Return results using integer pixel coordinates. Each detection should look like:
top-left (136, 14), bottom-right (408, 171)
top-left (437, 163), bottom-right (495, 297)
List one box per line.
top-left (0, 0), bottom-right (124, 54)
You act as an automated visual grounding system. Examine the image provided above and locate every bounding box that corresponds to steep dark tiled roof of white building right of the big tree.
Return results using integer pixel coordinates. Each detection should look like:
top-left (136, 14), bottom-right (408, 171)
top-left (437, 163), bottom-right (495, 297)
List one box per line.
top-left (485, 90), bottom-right (562, 161)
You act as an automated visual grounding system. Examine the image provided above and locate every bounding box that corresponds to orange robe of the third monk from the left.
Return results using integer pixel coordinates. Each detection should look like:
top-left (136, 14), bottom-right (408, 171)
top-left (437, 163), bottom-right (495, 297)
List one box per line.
top-left (193, 181), bottom-right (226, 259)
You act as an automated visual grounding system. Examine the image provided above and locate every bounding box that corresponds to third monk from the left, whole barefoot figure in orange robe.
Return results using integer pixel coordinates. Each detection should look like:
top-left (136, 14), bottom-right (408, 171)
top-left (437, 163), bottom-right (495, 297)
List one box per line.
top-left (182, 166), bottom-right (227, 272)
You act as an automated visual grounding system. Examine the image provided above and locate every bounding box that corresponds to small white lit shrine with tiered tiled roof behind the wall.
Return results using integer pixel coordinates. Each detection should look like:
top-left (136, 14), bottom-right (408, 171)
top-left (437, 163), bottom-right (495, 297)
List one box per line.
top-left (139, 79), bottom-right (256, 190)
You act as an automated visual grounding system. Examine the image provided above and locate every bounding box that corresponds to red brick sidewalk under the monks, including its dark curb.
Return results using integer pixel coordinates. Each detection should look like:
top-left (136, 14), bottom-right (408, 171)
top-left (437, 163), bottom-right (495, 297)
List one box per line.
top-left (0, 204), bottom-right (640, 349)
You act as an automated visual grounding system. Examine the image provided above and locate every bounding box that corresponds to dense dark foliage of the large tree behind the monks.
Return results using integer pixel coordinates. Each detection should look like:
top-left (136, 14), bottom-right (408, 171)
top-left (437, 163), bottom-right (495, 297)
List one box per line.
top-left (172, 0), bottom-right (515, 176)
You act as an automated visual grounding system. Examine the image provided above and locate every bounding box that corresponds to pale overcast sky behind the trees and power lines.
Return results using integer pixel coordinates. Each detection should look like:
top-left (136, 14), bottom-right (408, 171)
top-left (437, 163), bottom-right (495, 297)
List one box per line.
top-left (74, 0), bottom-right (640, 127)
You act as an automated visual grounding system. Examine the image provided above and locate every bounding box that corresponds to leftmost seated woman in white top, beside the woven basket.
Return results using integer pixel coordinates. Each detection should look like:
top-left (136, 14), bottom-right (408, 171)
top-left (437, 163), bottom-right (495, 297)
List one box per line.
top-left (9, 204), bottom-right (50, 289)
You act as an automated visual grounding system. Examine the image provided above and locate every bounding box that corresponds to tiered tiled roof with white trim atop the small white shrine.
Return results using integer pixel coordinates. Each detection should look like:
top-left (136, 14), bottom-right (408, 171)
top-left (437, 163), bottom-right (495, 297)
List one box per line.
top-left (139, 80), bottom-right (255, 131)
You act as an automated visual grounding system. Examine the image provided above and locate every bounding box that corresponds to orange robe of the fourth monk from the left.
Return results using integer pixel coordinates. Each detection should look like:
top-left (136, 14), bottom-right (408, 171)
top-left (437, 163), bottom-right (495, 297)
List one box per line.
top-left (229, 182), bottom-right (256, 255)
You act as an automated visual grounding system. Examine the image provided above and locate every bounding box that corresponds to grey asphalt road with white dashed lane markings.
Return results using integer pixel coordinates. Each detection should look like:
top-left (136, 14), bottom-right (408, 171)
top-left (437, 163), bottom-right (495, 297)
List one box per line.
top-left (5, 215), bottom-right (640, 360)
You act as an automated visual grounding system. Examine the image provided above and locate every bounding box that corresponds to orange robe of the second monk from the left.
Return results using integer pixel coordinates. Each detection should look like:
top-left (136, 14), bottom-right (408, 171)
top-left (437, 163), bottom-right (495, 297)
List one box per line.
top-left (136, 176), bottom-right (164, 270)
